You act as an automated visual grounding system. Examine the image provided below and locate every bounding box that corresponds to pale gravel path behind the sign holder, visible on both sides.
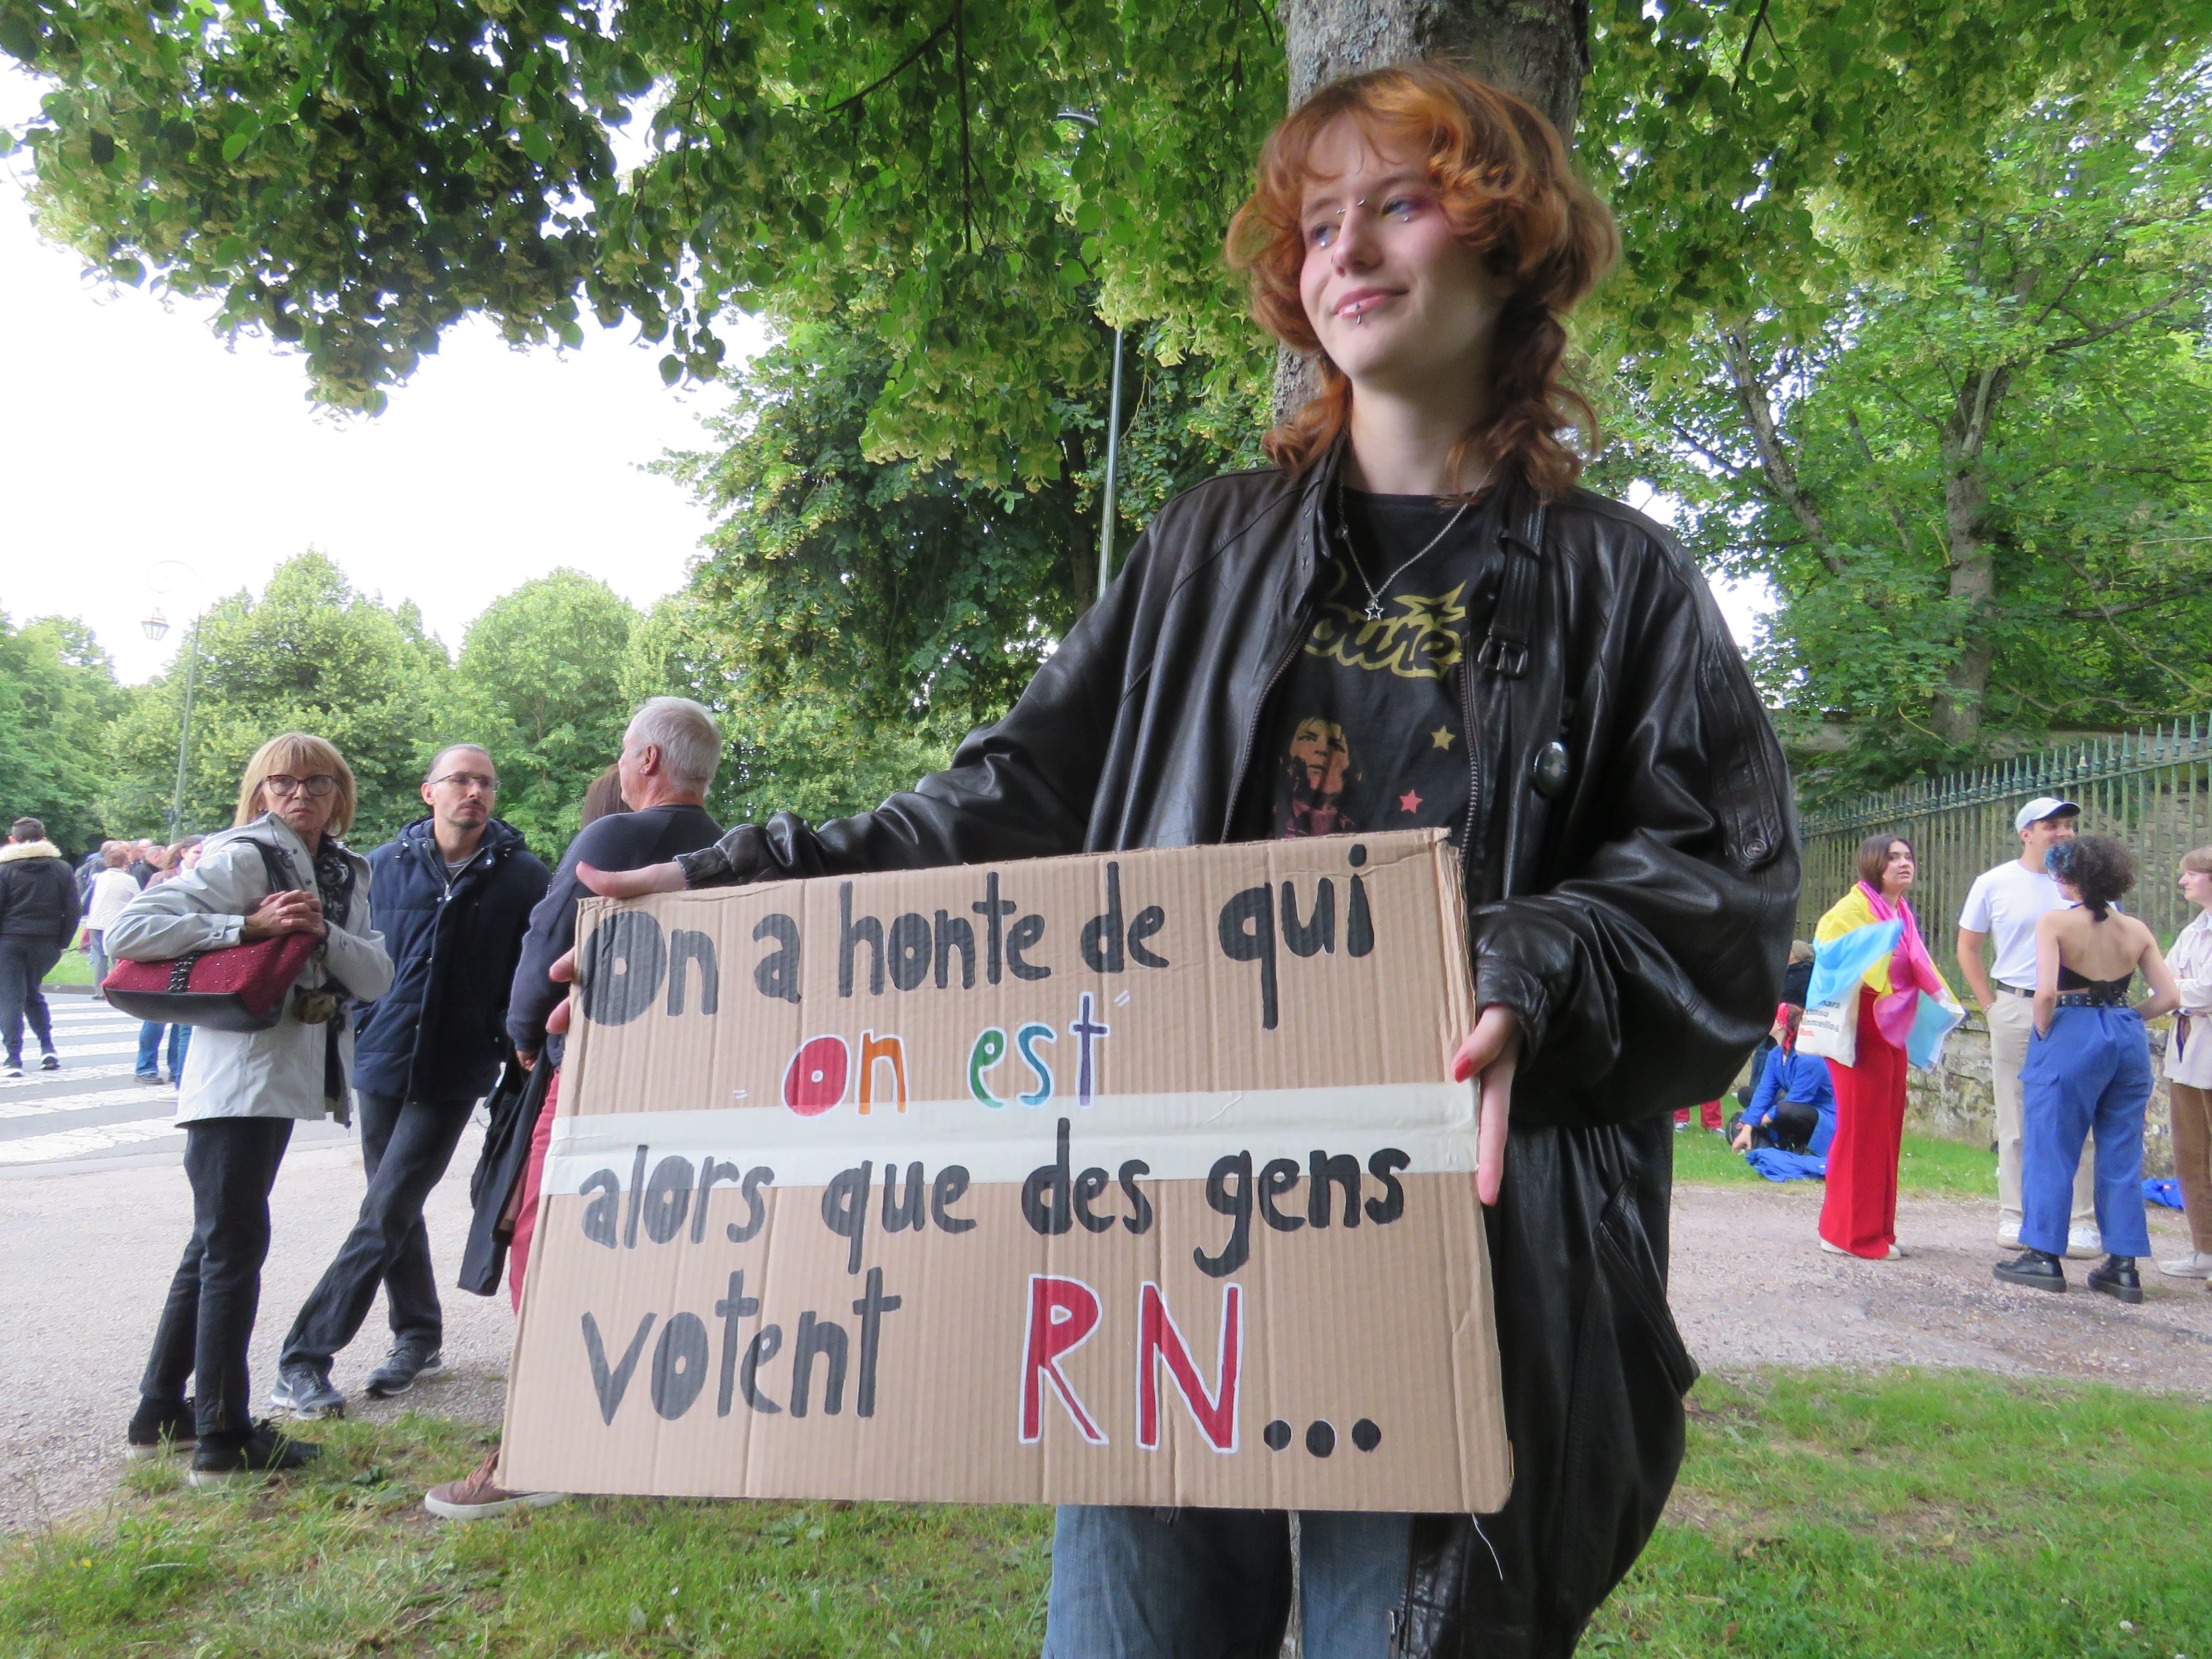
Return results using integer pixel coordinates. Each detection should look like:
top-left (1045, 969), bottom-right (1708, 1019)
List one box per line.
top-left (0, 1130), bottom-right (2212, 1531)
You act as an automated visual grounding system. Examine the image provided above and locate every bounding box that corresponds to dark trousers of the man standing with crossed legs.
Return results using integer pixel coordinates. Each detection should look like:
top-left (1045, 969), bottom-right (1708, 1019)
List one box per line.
top-left (279, 1088), bottom-right (473, 1367)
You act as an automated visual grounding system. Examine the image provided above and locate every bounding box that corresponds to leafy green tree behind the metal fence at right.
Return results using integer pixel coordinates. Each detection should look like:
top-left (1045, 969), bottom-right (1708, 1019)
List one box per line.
top-left (1623, 66), bottom-right (2212, 790)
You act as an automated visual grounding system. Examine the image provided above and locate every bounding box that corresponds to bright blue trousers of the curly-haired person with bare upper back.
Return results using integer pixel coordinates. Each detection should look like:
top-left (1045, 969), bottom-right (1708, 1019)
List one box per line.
top-left (2020, 1009), bottom-right (2150, 1256)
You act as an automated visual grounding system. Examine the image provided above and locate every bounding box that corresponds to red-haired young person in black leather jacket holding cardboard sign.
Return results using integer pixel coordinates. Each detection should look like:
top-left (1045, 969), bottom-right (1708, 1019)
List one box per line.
top-left (575, 64), bottom-right (1798, 1659)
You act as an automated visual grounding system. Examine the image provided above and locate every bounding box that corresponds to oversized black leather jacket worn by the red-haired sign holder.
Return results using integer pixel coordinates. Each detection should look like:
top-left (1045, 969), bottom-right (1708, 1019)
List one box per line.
top-left (679, 456), bottom-right (1798, 1659)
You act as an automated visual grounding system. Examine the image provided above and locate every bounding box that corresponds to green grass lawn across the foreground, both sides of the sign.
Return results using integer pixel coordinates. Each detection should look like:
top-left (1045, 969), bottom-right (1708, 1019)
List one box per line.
top-left (0, 1371), bottom-right (2212, 1659)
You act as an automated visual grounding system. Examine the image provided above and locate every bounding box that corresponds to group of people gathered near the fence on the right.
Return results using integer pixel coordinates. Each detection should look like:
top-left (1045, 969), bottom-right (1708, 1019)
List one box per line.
top-left (1725, 796), bottom-right (2212, 1303)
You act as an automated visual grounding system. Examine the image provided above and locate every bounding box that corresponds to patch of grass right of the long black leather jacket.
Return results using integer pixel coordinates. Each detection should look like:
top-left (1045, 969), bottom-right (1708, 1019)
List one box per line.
top-left (1582, 1371), bottom-right (2212, 1659)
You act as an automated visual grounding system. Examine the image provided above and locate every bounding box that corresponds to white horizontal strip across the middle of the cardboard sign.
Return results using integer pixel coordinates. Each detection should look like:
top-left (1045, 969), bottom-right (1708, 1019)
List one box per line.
top-left (544, 1084), bottom-right (1476, 1192)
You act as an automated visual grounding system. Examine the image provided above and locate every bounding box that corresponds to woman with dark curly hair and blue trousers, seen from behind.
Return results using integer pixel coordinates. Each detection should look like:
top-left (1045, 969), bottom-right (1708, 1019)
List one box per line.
top-left (1995, 836), bottom-right (2181, 1303)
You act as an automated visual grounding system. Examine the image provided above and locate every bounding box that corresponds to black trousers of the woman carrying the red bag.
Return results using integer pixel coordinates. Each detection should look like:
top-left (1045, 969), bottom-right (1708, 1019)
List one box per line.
top-left (139, 1117), bottom-right (292, 1433)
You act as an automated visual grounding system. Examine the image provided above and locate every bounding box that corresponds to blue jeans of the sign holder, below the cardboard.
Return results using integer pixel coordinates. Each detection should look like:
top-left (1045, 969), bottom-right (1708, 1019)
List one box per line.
top-left (1044, 1504), bottom-right (1414, 1659)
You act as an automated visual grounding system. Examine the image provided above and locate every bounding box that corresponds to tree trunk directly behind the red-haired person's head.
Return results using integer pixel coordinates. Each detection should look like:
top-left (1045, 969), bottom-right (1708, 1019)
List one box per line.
top-left (1274, 0), bottom-right (1590, 421)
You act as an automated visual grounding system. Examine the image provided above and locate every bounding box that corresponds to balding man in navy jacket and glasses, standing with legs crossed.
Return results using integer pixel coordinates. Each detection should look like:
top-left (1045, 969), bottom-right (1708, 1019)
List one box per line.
top-left (270, 743), bottom-right (551, 1418)
